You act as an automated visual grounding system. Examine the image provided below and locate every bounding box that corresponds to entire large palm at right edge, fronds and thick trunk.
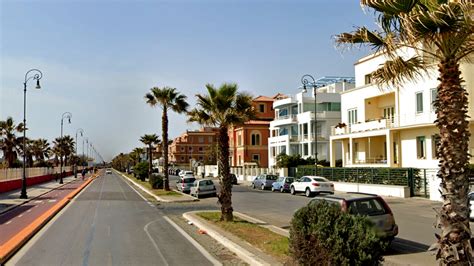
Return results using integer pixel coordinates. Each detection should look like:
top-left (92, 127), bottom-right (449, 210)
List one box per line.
top-left (336, 0), bottom-right (474, 265)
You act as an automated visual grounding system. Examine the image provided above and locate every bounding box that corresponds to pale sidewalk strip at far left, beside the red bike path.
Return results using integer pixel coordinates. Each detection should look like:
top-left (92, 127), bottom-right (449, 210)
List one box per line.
top-left (0, 176), bottom-right (75, 214)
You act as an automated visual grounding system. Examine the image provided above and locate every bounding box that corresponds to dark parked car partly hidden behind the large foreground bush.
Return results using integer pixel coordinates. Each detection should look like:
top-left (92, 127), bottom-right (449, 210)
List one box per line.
top-left (309, 192), bottom-right (398, 241)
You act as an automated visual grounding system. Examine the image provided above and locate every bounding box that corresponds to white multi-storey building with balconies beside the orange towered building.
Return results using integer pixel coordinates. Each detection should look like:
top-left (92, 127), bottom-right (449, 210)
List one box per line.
top-left (268, 77), bottom-right (355, 167)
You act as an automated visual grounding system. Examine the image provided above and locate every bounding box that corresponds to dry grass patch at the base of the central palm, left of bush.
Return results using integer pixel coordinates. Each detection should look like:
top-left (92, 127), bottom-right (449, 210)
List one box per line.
top-left (197, 212), bottom-right (289, 263)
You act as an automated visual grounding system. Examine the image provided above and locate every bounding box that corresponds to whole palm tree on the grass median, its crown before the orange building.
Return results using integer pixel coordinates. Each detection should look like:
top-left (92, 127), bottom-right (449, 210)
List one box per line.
top-left (188, 83), bottom-right (255, 221)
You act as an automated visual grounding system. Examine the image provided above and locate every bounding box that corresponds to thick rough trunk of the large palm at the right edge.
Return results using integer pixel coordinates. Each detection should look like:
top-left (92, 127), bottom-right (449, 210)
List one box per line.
top-left (435, 59), bottom-right (473, 265)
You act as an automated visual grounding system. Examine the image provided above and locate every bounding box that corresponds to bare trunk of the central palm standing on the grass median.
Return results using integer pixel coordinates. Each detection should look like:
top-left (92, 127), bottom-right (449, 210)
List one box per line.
top-left (218, 126), bottom-right (234, 222)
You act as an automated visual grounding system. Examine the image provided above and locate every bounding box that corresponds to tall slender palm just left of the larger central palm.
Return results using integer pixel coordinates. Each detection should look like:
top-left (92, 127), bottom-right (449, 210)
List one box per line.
top-left (145, 87), bottom-right (189, 190)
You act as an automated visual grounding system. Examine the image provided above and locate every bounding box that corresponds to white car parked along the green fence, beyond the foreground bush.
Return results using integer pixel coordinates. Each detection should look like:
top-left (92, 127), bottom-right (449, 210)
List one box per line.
top-left (290, 176), bottom-right (334, 197)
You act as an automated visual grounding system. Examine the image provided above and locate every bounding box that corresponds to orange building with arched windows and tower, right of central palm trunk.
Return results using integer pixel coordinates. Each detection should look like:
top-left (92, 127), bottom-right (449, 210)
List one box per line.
top-left (229, 93), bottom-right (286, 168)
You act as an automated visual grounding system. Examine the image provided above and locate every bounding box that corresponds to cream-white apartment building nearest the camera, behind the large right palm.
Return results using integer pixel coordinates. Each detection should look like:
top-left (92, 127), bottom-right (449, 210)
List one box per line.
top-left (330, 50), bottom-right (474, 168)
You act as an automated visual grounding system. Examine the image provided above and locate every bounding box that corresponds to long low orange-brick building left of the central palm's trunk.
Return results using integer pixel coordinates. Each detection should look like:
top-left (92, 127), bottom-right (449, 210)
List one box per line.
top-left (168, 127), bottom-right (218, 165)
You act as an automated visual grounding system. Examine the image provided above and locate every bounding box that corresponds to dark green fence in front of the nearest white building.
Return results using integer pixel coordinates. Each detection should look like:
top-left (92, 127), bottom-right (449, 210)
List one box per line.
top-left (295, 166), bottom-right (431, 197)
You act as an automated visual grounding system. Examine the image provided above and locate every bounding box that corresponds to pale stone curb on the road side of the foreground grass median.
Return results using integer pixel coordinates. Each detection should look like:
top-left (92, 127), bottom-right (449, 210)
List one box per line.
top-left (183, 211), bottom-right (271, 266)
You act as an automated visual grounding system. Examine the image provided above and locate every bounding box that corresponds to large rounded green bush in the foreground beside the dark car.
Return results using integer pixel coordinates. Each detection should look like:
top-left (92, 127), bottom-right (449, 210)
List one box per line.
top-left (290, 201), bottom-right (388, 265)
